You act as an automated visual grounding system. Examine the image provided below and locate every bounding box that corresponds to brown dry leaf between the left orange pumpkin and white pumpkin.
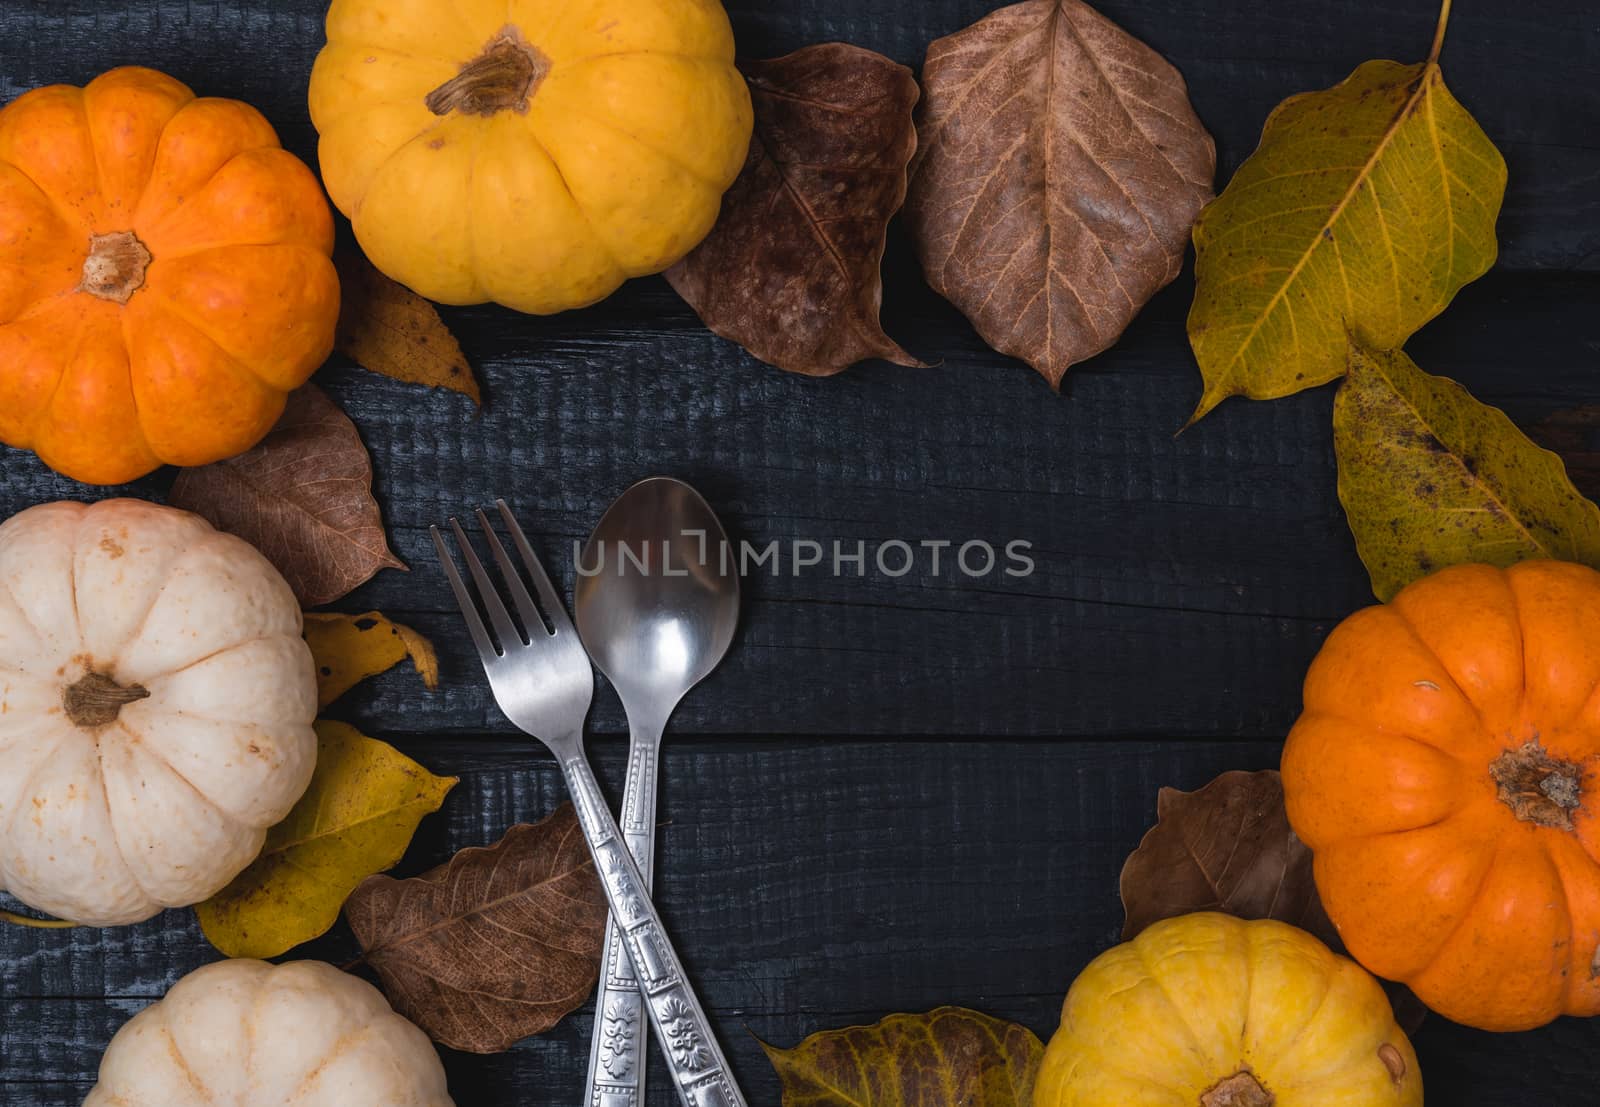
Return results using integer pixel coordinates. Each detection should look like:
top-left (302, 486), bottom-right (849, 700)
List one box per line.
top-left (168, 384), bottom-right (405, 608)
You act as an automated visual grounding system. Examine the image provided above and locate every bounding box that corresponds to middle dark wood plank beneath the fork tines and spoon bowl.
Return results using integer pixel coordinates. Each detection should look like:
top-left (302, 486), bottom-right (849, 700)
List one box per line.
top-left (0, 275), bottom-right (1600, 737)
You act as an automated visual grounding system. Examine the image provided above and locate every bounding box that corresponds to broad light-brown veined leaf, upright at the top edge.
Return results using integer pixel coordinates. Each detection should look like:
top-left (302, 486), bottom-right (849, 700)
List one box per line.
top-left (906, 0), bottom-right (1216, 387)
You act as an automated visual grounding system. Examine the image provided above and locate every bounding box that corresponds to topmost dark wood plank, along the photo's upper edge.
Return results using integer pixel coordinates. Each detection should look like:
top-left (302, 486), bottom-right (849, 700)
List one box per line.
top-left (0, 0), bottom-right (1600, 270)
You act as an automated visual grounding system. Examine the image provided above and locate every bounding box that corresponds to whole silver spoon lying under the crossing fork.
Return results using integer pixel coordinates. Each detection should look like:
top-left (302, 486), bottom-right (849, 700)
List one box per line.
top-left (574, 477), bottom-right (739, 1107)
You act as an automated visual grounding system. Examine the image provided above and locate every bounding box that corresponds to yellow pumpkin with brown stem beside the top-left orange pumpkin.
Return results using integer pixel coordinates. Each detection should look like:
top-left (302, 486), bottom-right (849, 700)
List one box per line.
top-left (310, 0), bottom-right (752, 314)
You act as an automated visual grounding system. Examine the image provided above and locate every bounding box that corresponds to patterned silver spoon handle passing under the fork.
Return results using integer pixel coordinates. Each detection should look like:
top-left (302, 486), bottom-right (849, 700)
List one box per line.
top-left (582, 726), bottom-right (661, 1107)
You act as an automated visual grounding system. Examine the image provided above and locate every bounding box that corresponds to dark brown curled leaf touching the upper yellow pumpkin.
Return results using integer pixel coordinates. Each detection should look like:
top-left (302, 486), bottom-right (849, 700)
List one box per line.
top-left (667, 43), bottom-right (922, 376)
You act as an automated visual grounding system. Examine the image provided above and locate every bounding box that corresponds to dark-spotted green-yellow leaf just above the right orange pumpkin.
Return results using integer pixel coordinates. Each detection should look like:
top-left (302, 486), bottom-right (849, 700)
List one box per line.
top-left (1333, 347), bottom-right (1600, 600)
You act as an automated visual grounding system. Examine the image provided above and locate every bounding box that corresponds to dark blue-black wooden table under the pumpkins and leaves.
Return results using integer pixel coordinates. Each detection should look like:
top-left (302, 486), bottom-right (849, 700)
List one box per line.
top-left (0, 0), bottom-right (1600, 1107)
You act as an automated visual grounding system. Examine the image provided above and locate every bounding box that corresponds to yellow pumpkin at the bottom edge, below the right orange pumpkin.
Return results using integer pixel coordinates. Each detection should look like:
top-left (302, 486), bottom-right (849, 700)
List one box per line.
top-left (1034, 912), bottom-right (1422, 1107)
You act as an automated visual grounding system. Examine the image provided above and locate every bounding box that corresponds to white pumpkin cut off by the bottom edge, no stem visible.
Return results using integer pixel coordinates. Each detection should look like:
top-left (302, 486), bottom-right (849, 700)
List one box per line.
top-left (83, 961), bottom-right (453, 1107)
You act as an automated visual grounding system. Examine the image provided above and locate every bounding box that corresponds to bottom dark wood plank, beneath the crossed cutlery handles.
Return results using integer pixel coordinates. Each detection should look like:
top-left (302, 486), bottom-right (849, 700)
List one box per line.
top-left (0, 739), bottom-right (1600, 1107)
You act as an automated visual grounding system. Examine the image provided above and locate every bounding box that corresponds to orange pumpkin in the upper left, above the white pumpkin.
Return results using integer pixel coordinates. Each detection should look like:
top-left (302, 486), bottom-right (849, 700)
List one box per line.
top-left (0, 69), bottom-right (339, 485)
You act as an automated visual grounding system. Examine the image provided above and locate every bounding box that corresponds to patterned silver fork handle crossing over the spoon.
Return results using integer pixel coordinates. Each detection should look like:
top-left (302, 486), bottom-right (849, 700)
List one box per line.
top-left (562, 748), bottom-right (746, 1107)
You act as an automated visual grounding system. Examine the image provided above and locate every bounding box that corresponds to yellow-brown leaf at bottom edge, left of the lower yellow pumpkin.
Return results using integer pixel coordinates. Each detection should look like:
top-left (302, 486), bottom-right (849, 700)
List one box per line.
top-left (762, 1008), bottom-right (1045, 1107)
